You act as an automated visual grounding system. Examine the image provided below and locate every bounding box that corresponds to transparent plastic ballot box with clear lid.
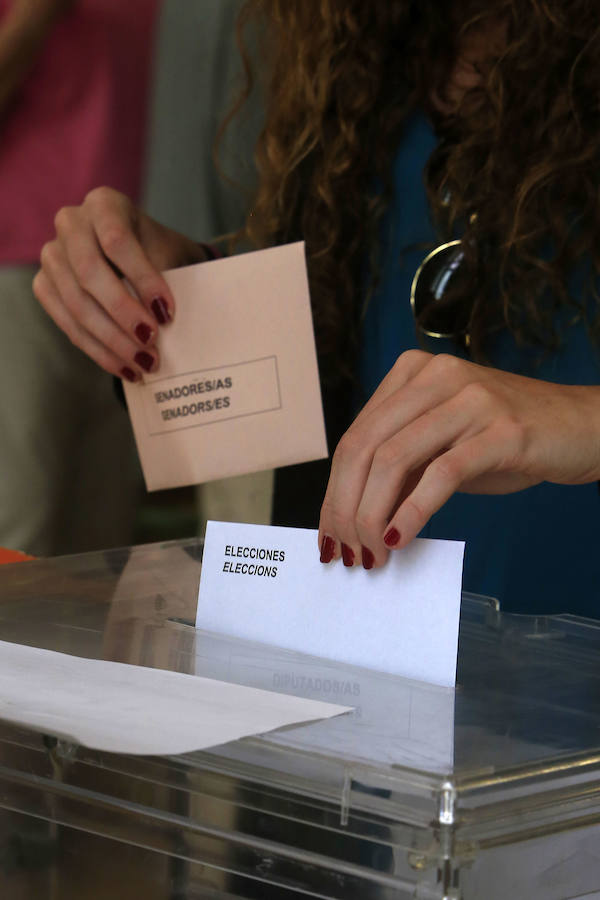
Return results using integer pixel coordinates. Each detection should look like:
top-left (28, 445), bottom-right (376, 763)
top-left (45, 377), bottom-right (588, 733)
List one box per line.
top-left (0, 541), bottom-right (600, 900)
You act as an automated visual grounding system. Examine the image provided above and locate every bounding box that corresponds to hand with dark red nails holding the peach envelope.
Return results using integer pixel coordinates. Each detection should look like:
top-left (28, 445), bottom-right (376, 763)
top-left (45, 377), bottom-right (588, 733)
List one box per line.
top-left (33, 187), bottom-right (207, 381)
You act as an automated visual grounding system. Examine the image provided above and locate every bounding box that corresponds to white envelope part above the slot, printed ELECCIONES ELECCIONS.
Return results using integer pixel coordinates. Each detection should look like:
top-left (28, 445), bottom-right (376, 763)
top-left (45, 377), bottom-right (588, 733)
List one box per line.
top-left (196, 522), bottom-right (464, 687)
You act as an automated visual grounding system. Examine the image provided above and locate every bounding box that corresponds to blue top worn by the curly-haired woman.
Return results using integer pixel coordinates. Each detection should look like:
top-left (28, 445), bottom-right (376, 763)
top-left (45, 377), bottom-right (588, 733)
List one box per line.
top-left (360, 115), bottom-right (600, 618)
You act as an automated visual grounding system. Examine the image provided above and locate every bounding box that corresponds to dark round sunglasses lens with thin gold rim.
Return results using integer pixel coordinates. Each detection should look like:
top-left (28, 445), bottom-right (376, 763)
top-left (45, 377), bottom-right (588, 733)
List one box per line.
top-left (413, 241), bottom-right (470, 337)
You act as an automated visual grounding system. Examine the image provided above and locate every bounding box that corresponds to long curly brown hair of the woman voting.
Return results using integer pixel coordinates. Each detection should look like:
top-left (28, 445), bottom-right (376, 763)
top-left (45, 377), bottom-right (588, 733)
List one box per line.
top-left (227, 0), bottom-right (600, 379)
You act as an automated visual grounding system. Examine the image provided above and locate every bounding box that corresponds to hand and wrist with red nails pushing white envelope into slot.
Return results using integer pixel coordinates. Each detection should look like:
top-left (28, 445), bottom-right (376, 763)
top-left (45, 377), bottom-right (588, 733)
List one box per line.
top-left (319, 350), bottom-right (600, 569)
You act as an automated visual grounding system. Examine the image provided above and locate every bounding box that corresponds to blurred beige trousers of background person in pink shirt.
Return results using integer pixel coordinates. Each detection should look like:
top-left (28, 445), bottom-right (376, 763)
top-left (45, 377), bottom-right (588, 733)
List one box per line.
top-left (0, 266), bottom-right (141, 556)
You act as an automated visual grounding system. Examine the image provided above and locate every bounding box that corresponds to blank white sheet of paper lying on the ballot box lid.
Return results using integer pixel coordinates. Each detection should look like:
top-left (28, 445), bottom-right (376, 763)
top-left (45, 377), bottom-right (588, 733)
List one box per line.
top-left (0, 641), bottom-right (350, 755)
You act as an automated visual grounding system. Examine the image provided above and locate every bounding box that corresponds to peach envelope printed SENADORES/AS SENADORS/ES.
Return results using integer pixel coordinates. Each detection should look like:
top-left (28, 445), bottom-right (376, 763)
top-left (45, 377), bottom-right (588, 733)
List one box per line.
top-left (124, 243), bottom-right (327, 491)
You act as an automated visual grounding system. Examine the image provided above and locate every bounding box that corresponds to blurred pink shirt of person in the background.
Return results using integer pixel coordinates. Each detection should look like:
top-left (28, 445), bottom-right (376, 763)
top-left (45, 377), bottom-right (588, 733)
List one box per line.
top-left (0, 0), bottom-right (160, 263)
